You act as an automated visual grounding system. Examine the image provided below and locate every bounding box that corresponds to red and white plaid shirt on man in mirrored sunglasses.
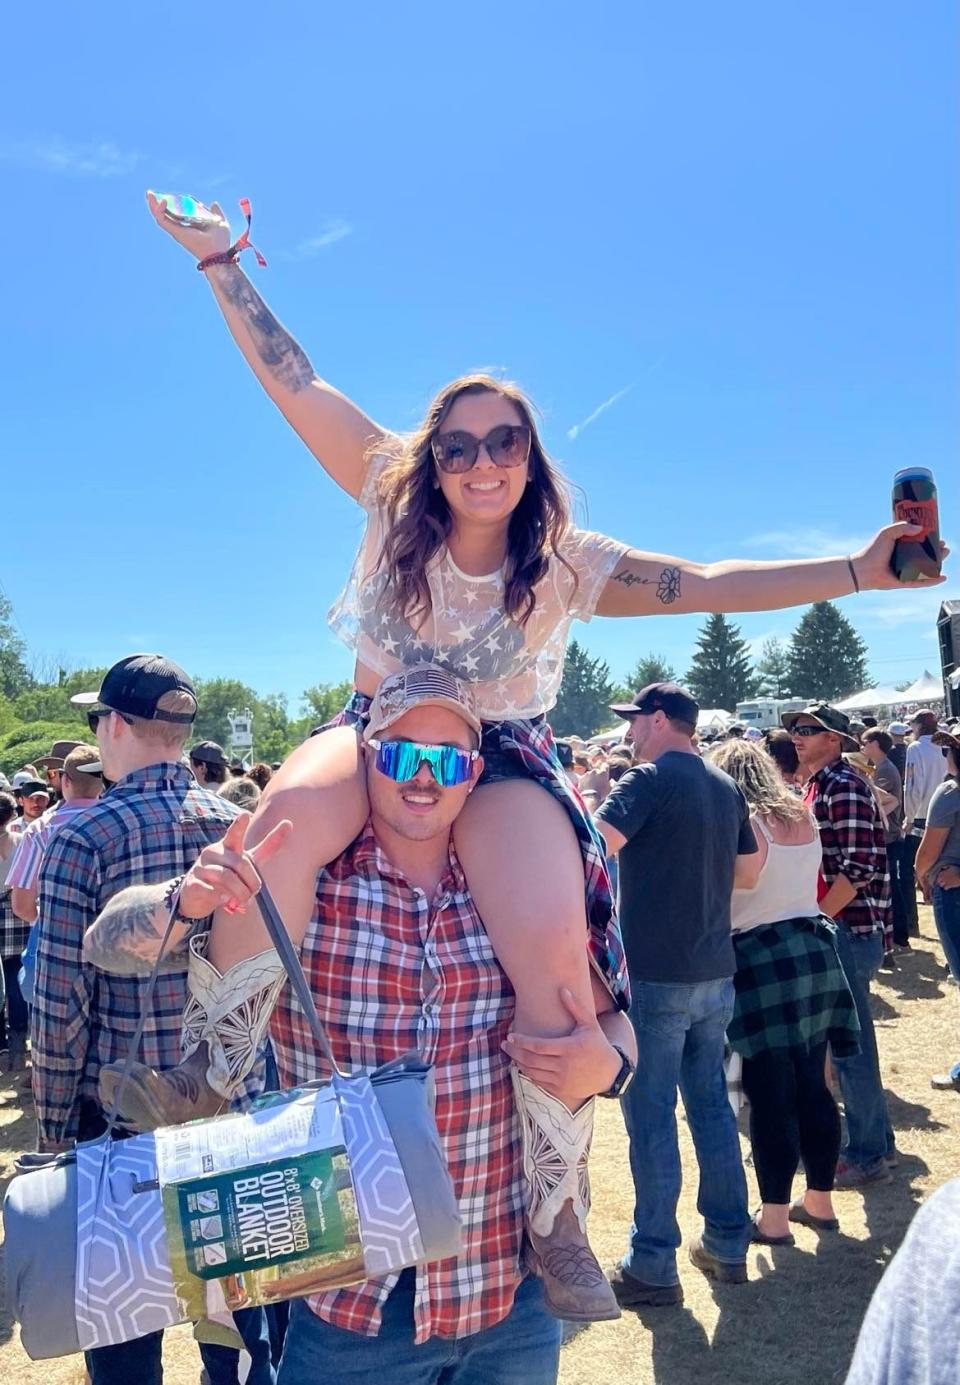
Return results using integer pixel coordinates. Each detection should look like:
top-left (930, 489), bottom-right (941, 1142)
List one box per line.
top-left (272, 824), bottom-right (524, 1342)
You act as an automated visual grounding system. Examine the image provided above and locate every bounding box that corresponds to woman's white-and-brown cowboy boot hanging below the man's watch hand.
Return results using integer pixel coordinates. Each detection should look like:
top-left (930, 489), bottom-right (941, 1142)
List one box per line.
top-left (511, 1066), bottom-right (621, 1323)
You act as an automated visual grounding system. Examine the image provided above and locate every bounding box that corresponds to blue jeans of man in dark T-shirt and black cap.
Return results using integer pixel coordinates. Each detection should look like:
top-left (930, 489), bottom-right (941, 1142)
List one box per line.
top-left (622, 978), bottom-right (752, 1285)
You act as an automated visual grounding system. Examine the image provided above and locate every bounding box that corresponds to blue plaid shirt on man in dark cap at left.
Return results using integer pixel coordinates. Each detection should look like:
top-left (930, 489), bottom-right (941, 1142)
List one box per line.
top-left (30, 762), bottom-right (238, 1143)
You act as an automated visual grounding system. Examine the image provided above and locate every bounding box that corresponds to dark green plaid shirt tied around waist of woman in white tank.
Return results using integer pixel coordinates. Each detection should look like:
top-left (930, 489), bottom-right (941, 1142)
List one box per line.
top-left (727, 915), bottom-right (860, 1058)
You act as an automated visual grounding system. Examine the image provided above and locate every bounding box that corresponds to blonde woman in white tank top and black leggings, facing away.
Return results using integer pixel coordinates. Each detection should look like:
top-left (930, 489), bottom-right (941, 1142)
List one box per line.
top-left (712, 741), bottom-right (857, 1245)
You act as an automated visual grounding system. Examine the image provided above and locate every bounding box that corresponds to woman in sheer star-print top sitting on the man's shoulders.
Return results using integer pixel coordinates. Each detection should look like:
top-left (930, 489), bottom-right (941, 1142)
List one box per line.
top-left (103, 186), bottom-right (936, 1319)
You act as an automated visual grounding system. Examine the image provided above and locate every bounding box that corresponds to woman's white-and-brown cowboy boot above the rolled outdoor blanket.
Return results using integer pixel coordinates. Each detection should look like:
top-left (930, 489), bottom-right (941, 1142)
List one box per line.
top-left (98, 933), bottom-right (287, 1130)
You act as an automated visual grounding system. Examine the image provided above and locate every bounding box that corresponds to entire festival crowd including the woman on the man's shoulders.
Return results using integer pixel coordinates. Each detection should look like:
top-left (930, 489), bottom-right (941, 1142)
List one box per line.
top-left (4, 186), bottom-right (960, 1385)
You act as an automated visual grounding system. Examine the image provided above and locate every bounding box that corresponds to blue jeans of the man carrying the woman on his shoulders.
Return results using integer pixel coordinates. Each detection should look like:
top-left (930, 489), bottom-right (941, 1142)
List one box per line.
top-left (277, 1271), bottom-right (561, 1385)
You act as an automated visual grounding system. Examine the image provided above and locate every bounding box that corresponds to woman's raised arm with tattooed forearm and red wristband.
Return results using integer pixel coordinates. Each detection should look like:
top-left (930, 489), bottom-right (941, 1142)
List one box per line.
top-left (147, 193), bottom-right (388, 497)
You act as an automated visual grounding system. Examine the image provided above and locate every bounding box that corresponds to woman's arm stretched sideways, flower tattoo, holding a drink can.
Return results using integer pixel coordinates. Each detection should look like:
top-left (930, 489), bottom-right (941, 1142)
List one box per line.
top-left (597, 524), bottom-right (949, 615)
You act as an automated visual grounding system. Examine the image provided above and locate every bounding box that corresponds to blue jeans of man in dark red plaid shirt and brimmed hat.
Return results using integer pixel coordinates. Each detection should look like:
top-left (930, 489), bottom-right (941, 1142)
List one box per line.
top-left (833, 924), bottom-right (894, 1168)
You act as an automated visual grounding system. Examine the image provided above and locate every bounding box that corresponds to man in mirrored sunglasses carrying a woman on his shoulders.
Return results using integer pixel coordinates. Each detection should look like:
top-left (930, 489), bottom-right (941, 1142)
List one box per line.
top-left (86, 668), bottom-right (636, 1385)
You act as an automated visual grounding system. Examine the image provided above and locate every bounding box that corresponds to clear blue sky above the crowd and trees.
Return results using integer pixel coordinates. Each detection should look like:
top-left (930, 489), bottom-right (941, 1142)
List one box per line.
top-left (0, 0), bottom-right (960, 705)
